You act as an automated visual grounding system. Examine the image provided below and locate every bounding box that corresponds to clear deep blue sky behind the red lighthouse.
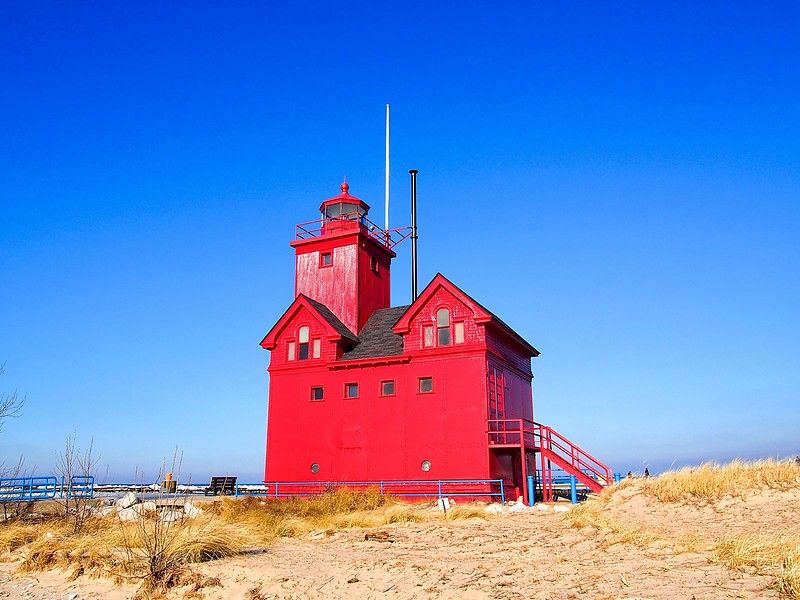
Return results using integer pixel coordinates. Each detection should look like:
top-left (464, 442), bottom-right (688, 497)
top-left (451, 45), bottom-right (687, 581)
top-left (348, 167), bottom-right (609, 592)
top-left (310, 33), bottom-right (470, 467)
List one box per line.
top-left (0, 1), bottom-right (800, 481)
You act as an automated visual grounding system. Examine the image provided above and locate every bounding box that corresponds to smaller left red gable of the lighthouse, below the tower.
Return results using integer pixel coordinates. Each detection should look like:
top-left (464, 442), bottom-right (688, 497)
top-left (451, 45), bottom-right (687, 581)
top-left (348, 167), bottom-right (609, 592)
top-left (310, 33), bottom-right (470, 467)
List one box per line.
top-left (261, 294), bottom-right (358, 370)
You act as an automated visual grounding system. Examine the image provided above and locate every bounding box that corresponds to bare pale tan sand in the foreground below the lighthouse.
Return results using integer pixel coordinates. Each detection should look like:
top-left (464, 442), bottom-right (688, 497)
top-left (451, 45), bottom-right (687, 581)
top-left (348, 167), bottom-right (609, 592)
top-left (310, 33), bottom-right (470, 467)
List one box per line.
top-left (0, 478), bottom-right (800, 600)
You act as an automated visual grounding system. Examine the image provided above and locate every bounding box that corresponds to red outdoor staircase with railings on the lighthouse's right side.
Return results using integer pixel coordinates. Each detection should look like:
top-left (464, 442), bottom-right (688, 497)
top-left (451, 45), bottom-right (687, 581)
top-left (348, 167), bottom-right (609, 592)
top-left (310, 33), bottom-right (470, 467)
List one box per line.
top-left (488, 419), bottom-right (613, 500)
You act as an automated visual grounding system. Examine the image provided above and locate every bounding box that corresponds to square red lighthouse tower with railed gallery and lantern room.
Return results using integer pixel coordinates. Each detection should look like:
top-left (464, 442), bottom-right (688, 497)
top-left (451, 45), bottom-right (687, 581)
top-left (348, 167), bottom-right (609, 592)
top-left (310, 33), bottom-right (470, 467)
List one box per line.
top-left (291, 182), bottom-right (396, 335)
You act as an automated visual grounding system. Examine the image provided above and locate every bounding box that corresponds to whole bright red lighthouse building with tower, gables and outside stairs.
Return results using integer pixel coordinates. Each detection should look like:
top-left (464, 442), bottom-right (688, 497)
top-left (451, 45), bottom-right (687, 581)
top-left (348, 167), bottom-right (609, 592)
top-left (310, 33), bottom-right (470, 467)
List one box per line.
top-left (261, 183), bottom-right (611, 498)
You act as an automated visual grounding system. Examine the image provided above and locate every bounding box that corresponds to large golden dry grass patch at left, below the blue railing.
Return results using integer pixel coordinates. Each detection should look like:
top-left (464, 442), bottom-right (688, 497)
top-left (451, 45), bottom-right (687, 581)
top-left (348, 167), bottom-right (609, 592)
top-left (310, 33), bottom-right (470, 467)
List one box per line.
top-left (0, 489), bottom-right (485, 598)
